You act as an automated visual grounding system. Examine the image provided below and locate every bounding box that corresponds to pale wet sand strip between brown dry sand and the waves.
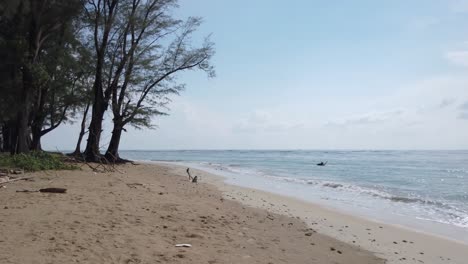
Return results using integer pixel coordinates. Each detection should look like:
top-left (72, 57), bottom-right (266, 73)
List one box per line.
top-left (154, 161), bottom-right (468, 264)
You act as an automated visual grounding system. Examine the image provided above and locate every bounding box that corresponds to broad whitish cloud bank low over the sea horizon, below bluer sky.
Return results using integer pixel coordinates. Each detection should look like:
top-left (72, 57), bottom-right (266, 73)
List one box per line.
top-left (43, 74), bottom-right (468, 149)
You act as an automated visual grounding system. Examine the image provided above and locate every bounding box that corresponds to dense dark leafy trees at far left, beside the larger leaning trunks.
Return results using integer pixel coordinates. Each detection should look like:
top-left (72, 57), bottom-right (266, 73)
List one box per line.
top-left (0, 0), bottom-right (91, 152)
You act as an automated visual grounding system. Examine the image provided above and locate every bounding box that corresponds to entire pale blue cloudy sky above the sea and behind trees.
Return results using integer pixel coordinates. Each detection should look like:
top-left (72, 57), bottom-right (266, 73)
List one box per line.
top-left (43, 0), bottom-right (468, 150)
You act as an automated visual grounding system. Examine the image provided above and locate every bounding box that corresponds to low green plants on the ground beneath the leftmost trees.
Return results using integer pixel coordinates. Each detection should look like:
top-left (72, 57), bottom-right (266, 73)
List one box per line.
top-left (0, 151), bottom-right (77, 171)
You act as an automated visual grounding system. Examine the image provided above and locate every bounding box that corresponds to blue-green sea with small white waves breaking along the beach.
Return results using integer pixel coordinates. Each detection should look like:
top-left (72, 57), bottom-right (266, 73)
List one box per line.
top-left (121, 150), bottom-right (468, 242)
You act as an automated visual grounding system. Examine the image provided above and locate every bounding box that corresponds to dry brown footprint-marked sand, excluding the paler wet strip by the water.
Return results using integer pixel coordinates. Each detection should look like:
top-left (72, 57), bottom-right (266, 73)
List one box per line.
top-left (0, 164), bottom-right (385, 264)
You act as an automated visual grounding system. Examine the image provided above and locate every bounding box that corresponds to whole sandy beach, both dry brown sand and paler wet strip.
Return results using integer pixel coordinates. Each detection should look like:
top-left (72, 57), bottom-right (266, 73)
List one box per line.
top-left (0, 164), bottom-right (468, 264)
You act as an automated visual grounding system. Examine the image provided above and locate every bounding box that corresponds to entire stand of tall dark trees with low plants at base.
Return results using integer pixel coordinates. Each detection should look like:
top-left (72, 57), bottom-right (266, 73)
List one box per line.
top-left (0, 0), bottom-right (214, 163)
